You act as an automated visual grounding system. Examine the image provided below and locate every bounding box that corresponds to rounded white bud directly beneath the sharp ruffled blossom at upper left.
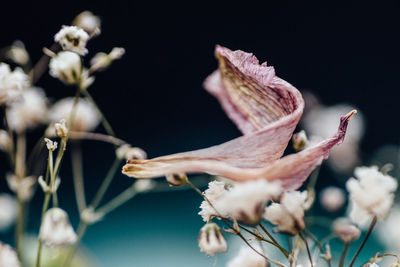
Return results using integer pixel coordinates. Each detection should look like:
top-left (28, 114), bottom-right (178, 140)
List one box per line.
top-left (49, 51), bottom-right (82, 84)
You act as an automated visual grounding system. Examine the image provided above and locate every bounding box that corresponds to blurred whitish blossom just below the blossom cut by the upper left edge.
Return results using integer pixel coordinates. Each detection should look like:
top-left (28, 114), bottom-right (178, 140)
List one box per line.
top-left (7, 88), bottom-right (47, 132)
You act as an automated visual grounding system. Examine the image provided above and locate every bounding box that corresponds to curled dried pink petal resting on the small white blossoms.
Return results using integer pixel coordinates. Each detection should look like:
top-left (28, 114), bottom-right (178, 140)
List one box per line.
top-left (122, 46), bottom-right (356, 189)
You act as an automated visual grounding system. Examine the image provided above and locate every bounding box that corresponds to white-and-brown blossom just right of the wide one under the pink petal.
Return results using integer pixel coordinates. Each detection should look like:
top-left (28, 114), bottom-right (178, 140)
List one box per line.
top-left (263, 191), bottom-right (307, 235)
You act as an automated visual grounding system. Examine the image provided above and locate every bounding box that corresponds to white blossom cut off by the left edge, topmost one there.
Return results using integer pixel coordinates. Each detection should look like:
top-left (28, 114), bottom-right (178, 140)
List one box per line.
top-left (0, 62), bottom-right (30, 105)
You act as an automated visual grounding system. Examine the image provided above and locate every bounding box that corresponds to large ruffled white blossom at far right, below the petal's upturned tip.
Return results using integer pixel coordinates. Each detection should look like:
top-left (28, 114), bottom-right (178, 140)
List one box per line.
top-left (346, 166), bottom-right (397, 226)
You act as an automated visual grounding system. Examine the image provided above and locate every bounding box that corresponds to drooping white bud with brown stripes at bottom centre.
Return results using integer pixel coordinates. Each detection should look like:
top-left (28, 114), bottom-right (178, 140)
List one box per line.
top-left (198, 223), bottom-right (227, 256)
